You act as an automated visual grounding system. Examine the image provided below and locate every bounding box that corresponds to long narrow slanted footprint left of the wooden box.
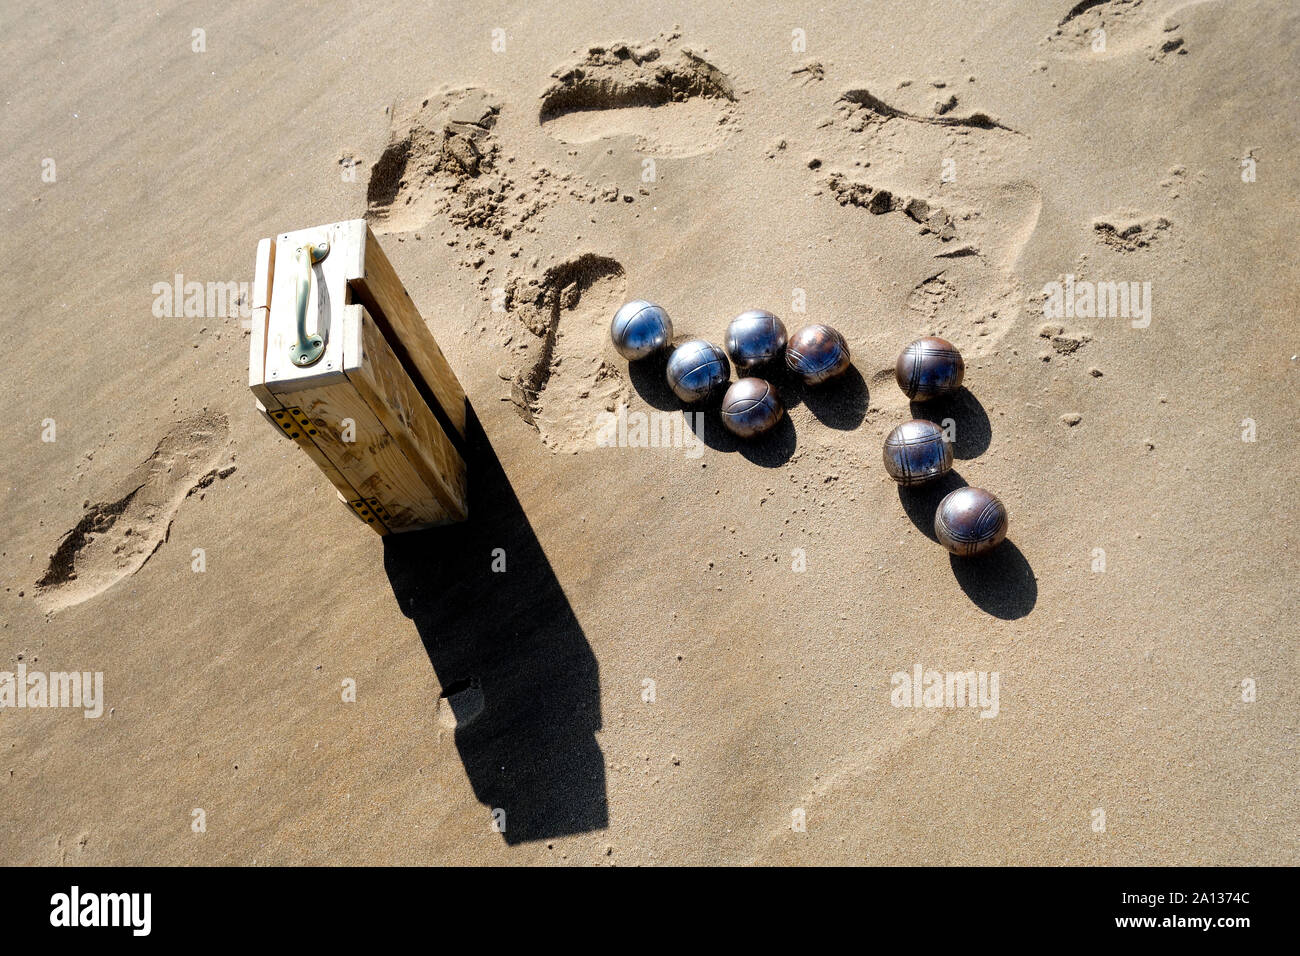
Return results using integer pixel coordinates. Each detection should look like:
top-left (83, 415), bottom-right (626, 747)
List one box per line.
top-left (36, 415), bottom-right (234, 610)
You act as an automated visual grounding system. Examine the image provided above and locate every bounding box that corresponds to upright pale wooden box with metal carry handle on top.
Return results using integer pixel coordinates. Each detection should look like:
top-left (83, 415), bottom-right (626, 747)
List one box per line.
top-left (248, 220), bottom-right (467, 535)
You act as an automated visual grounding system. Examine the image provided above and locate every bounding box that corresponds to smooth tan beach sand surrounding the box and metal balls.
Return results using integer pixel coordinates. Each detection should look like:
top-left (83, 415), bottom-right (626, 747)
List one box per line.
top-left (0, 0), bottom-right (1300, 864)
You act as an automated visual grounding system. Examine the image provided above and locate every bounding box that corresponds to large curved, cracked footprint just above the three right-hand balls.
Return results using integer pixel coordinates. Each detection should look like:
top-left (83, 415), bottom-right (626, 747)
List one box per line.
top-left (813, 81), bottom-right (1043, 355)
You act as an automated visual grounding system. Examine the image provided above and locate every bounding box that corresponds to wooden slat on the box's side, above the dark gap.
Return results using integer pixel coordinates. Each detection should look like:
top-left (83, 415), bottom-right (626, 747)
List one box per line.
top-left (339, 220), bottom-right (465, 440)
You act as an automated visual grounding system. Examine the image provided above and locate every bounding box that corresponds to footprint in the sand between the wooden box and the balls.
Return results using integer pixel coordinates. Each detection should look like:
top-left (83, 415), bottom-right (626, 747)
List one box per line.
top-left (501, 252), bottom-right (632, 451)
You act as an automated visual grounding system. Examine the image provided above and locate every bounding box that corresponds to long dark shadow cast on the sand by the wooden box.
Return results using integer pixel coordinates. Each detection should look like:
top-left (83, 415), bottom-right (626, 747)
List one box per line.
top-left (384, 410), bottom-right (608, 845)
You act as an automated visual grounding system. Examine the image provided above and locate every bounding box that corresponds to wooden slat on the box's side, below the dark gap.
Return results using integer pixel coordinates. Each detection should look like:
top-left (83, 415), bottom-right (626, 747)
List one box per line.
top-left (343, 304), bottom-right (468, 520)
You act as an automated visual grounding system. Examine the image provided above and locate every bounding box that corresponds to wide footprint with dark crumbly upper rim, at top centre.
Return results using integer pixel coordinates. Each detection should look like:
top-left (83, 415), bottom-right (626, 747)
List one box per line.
top-left (538, 34), bottom-right (736, 156)
